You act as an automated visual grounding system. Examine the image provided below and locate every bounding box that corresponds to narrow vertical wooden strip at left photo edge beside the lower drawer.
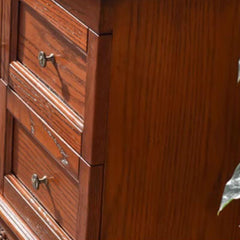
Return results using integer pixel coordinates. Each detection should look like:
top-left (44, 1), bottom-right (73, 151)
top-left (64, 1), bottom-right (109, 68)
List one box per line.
top-left (0, 79), bottom-right (7, 192)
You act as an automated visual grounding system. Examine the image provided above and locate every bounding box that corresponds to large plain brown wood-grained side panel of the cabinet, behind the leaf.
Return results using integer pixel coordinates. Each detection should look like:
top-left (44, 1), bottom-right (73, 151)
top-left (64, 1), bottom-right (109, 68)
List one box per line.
top-left (101, 0), bottom-right (240, 240)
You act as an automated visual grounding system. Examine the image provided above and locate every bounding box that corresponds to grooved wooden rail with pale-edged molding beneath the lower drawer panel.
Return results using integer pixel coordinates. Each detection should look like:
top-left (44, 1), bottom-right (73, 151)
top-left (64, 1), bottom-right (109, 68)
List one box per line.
top-left (1, 175), bottom-right (72, 240)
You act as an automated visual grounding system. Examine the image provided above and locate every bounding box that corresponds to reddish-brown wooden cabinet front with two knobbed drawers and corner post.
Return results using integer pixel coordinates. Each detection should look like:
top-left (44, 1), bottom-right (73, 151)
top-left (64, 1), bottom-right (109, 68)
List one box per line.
top-left (0, 0), bottom-right (108, 240)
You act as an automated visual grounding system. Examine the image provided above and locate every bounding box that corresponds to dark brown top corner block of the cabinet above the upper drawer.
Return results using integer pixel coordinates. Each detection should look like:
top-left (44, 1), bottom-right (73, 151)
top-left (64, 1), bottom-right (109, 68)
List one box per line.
top-left (54, 0), bottom-right (115, 34)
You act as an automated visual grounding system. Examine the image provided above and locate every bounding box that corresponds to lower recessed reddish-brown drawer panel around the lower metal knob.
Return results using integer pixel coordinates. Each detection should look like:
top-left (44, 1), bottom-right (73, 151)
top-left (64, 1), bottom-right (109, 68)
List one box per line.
top-left (12, 121), bottom-right (79, 238)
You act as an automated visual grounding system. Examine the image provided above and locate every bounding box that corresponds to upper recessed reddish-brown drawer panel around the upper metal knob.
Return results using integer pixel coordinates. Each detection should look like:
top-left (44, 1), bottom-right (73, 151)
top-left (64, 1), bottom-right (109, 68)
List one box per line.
top-left (17, 1), bottom-right (87, 118)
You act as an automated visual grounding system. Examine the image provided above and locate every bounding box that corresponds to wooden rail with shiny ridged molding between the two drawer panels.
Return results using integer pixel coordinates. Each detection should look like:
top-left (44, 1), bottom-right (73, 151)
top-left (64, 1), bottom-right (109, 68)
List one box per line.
top-left (10, 63), bottom-right (83, 153)
